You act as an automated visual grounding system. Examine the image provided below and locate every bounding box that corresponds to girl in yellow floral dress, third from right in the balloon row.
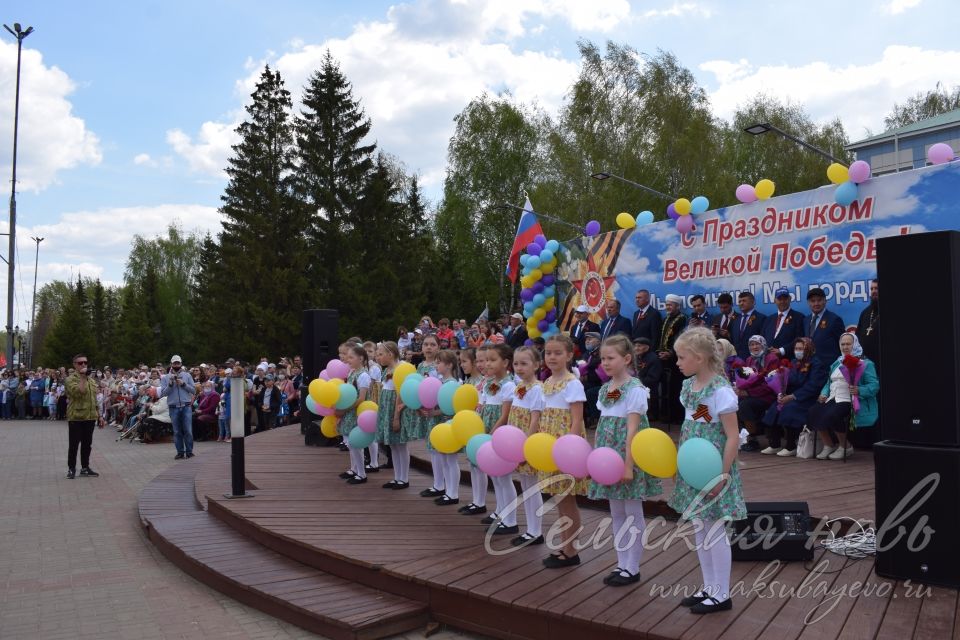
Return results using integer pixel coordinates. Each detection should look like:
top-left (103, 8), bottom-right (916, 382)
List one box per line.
top-left (540, 335), bottom-right (589, 569)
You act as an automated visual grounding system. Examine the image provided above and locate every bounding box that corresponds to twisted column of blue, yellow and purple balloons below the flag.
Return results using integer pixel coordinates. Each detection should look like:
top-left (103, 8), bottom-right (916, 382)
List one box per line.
top-left (520, 235), bottom-right (560, 339)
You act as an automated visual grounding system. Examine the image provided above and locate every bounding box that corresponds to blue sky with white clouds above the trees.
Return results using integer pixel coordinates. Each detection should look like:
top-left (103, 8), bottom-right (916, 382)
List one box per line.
top-left (0, 0), bottom-right (960, 326)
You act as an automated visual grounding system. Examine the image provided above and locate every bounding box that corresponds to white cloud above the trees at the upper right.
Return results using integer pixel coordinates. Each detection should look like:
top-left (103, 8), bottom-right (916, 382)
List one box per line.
top-left (699, 45), bottom-right (960, 140)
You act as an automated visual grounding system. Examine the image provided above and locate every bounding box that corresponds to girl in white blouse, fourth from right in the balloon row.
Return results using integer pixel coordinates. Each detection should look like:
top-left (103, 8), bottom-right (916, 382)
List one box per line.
top-left (507, 347), bottom-right (544, 547)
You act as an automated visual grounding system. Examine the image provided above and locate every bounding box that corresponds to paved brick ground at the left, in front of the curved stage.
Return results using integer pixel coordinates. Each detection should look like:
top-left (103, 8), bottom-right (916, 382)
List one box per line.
top-left (0, 420), bottom-right (478, 640)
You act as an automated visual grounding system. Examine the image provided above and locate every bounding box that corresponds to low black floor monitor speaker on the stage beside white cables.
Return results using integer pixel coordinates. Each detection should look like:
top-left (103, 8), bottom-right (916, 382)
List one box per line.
top-left (730, 502), bottom-right (813, 561)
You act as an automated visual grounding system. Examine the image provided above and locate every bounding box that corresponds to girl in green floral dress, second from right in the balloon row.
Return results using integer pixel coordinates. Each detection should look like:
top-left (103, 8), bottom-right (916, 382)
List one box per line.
top-left (589, 334), bottom-right (663, 587)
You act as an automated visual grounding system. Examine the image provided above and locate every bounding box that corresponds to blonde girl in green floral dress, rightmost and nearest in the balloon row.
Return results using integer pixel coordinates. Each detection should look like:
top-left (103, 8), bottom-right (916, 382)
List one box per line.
top-left (668, 327), bottom-right (747, 613)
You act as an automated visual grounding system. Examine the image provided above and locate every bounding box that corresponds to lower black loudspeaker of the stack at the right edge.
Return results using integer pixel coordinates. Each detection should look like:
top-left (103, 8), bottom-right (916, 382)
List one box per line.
top-left (873, 442), bottom-right (960, 587)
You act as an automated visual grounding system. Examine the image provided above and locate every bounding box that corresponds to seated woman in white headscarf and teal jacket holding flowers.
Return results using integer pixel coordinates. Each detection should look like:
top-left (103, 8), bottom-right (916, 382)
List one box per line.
top-left (807, 333), bottom-right (880, 460)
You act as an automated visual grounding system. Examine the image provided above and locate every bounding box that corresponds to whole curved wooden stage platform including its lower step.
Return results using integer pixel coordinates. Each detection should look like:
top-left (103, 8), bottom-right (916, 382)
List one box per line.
top-left (141, 426), bottom-right (960, 640)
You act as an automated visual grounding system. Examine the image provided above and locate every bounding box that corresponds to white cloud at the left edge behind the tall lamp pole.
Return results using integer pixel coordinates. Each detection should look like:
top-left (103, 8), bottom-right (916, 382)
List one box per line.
top-left (0, 40), bottom-right (102, 192)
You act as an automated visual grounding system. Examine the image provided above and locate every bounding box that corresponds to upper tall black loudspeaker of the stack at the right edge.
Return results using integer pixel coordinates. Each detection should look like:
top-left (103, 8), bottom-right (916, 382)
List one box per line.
top-left (877, 231), bottom-right (960, 446)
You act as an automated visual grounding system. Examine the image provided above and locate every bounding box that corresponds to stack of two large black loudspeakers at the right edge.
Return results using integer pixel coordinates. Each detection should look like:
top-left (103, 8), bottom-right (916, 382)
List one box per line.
top-left (873, 231), bottom-right (960, 587)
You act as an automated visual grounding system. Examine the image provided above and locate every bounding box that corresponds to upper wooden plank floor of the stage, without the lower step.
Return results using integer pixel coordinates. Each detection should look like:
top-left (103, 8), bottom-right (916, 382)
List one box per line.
top-left (141, 426), bottom-right (960, 640)
